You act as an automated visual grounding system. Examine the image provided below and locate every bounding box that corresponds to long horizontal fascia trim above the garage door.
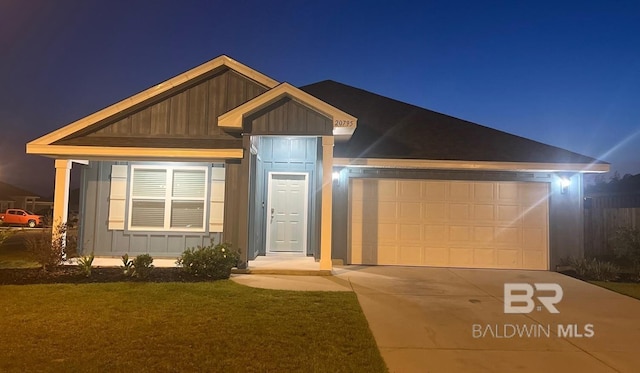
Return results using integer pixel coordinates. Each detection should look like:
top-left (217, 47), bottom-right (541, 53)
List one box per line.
top-left (333, 158), bottom-right (609, 173)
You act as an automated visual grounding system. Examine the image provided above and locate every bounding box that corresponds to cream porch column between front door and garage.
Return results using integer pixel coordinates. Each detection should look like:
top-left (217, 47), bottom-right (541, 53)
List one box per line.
top-left (320, 136), bottom-right (333, 270)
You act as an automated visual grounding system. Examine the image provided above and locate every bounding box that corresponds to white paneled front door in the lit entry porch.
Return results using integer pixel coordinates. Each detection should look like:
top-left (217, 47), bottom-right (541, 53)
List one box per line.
top-left (267, 172), bottom-right (308, 254)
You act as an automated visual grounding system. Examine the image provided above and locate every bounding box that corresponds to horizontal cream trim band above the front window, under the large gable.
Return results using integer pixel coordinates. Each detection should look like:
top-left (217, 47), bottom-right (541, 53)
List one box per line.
top-left (27, 143), bottom-right (244, 161)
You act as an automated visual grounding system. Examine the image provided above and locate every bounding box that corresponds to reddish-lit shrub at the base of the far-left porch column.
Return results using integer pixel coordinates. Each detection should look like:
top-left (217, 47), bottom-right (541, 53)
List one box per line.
top-left (25, 223), bottom-right (72, 271)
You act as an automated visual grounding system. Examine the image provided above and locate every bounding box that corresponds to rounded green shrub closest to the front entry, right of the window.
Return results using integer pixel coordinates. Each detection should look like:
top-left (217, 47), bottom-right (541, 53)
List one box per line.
top-left (176, 240), bottom-right (240, 279)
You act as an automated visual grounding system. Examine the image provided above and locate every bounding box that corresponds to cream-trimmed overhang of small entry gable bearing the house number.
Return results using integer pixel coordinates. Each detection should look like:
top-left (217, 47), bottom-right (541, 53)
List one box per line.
top-left (218, 83), bottom-right (358, 141)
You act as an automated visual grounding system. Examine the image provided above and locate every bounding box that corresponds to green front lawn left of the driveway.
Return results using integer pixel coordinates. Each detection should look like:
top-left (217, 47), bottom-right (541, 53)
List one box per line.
top-left (0, 281), bottom-right (387, 372)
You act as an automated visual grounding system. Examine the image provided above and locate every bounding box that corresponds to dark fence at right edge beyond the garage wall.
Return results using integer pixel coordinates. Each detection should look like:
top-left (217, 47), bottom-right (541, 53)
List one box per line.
top-left (584, 194), bottom-right (640, 256)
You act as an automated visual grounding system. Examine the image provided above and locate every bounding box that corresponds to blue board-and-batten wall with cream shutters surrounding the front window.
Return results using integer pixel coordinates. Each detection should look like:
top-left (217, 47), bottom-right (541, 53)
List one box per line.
top-left (78, 161), bottom-right (224, 258)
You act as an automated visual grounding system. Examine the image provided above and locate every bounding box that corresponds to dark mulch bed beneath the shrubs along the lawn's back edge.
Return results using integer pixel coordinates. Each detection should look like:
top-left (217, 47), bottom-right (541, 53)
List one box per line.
top-left (0, 265), bottom-right (211, 285)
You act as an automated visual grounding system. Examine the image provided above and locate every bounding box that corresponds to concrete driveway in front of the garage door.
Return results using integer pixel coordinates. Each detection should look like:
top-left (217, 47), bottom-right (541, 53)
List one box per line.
top-left (334, 266), bottom-right (640, 372)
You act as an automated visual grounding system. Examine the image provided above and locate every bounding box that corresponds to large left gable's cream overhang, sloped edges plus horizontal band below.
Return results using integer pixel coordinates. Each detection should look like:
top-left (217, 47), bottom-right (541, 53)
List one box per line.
top-left (27, 55), bottom-right (278, 158)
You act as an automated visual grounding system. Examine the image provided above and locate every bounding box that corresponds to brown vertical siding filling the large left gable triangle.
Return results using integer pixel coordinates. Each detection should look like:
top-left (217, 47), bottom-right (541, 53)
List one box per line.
top-left (56, 69), bottom-right (267, 148)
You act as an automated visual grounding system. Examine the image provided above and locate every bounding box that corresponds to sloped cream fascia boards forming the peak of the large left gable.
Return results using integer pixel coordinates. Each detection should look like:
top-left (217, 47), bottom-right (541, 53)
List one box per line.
top-left (29, 55), bottom-right (278, 145)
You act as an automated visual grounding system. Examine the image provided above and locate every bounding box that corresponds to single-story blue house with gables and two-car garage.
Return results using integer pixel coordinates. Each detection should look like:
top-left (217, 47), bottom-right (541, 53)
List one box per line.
top-left (27, 56), bottom-right (609, 270)
